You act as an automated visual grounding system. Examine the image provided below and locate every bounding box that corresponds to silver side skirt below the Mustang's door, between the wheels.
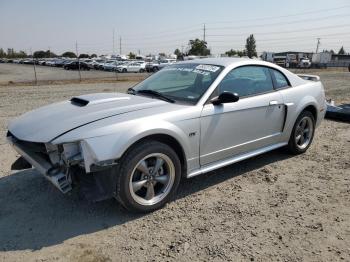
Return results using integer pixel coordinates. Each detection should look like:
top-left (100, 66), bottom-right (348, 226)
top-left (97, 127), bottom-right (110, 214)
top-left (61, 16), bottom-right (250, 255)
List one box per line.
top-left (187, 142), bottom-right (288, 178)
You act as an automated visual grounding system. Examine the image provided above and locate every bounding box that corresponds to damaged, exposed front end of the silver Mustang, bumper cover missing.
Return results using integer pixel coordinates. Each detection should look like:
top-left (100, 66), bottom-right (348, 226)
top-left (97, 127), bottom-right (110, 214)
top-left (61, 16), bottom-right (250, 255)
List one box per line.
top-left (7, 133), bottom-right (116, 201)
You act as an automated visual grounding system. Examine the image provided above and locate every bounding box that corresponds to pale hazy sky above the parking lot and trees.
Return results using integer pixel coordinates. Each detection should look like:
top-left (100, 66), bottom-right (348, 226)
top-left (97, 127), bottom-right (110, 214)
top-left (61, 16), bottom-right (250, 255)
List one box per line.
top-left (0, 0), bottom-right (350, 55)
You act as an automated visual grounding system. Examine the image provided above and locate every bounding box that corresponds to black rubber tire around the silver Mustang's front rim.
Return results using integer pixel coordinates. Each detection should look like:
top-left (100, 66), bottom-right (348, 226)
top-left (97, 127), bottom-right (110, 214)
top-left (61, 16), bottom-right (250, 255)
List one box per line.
top-left (116, 140), bottom-right (181, 213)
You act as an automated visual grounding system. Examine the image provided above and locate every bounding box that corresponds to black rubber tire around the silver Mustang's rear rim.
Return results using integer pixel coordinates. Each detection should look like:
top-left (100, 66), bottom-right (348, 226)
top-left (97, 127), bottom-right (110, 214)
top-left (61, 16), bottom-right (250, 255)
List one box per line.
top-left (288, 111), bottom-right (315, 155)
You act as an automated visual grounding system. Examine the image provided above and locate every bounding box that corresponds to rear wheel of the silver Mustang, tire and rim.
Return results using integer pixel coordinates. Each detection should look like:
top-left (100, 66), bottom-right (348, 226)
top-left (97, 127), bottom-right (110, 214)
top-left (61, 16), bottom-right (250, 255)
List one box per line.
top-left (288, 111), bottom-right (315, 154)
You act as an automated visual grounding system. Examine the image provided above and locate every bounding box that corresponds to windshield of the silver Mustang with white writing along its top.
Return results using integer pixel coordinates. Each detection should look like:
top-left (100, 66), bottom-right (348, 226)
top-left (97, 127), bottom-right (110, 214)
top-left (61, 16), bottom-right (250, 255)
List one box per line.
top-left (133, 63), bottom-right (223, 104)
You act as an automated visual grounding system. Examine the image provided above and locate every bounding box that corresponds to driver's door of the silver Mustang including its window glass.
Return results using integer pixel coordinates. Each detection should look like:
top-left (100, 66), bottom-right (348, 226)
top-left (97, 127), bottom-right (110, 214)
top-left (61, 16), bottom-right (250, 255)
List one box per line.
top-left (200, 66), bottom-right (285, 165)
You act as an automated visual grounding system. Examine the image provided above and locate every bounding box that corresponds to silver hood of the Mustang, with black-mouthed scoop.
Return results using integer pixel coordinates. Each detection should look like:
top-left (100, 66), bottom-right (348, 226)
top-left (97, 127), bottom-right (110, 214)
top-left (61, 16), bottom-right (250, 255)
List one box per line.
top-left (8, 93), bottom-right (168, 142)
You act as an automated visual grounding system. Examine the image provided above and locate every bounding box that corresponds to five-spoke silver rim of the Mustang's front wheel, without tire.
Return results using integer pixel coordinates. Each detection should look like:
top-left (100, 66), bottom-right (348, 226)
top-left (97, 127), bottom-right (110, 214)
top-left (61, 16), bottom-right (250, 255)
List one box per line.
top-left (130, 153), bottom-right (175, 205)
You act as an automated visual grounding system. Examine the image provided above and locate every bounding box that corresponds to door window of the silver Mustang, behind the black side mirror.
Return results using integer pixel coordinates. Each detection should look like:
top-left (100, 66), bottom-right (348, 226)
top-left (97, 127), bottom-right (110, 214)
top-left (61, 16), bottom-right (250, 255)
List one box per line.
top-left (219, 66), bottom-right (273, 97)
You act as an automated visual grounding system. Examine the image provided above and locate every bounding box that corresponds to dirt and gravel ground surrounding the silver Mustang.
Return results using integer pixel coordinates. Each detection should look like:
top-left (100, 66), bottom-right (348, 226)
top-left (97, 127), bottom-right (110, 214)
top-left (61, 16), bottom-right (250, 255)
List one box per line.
top-left (0, 68), bottom-right (350, 261)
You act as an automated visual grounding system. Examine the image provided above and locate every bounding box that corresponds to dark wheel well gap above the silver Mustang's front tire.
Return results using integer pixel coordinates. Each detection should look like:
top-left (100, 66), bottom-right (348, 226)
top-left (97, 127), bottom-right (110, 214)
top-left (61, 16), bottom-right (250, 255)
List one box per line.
top-left (124, 134), bottom-right (187, 175)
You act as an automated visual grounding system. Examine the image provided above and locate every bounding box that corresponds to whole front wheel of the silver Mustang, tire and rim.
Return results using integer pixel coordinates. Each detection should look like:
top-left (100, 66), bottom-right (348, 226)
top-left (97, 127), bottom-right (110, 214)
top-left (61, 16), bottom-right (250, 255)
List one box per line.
top-left (116, 141), bottom-right (181, 212)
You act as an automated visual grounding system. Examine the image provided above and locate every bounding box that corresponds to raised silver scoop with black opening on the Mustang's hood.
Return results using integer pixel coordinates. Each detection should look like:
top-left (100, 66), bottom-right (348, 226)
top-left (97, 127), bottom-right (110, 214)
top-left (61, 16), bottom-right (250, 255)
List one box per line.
top-left (70, 94), bottom-right (130, 107)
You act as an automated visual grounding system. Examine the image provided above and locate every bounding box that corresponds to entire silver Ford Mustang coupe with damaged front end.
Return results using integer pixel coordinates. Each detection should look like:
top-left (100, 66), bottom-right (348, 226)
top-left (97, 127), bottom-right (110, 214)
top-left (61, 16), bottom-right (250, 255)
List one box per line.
top-left (7, 58), bottom-right (326, 212)
